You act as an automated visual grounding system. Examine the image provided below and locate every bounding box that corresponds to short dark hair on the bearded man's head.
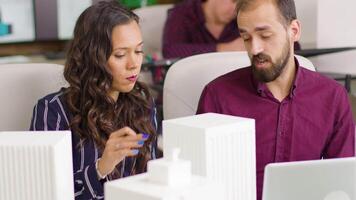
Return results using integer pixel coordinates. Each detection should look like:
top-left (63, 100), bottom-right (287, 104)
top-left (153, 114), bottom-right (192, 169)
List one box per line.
top-left (236, 0), bottom-right (297, 25)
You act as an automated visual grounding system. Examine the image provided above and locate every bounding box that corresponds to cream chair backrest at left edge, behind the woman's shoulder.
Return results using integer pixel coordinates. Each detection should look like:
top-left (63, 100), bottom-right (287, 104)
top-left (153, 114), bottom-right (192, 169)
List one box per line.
top-left (0, 64), bottom-right (66, 131)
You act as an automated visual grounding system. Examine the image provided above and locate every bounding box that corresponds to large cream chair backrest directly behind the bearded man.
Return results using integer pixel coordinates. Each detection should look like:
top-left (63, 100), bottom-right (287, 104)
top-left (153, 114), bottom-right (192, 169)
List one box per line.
top-left (163, 51), bottom-right (315, 119)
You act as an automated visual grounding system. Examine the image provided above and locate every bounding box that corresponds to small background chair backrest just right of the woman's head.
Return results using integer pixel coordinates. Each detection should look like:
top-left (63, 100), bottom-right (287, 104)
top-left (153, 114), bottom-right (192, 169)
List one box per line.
top-left (134, 4), bottom-right (173, 58)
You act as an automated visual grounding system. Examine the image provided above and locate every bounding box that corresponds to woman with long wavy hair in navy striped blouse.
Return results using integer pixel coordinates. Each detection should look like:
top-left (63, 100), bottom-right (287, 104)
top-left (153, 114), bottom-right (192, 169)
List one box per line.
top-left (30, 1), bottom-right (156, 199)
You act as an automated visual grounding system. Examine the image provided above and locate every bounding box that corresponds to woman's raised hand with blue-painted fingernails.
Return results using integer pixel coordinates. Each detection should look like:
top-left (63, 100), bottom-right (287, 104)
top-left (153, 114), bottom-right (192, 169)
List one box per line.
top-left (97, 127), bottom-right (148, 176)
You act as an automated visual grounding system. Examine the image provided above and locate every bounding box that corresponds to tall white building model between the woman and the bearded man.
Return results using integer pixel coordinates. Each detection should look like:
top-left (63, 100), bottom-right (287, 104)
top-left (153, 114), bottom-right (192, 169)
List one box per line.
top-left (163, 113), bottom-right (256, 200)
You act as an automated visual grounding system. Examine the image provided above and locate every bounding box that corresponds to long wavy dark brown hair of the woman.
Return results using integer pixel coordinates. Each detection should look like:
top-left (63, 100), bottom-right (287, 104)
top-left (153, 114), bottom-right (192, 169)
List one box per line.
top-left (64, 1), bottom-right (156, 173)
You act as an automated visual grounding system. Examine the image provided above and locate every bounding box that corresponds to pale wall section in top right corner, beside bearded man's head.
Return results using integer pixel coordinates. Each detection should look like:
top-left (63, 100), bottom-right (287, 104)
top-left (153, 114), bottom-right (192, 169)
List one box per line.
top-left (295, 0), bottom-right (356, 48)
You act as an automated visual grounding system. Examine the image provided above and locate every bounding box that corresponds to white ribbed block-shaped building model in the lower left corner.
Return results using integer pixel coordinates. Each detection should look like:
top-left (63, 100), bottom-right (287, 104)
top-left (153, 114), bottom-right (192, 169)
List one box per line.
top-left (0, 131), bottom-right (74, 200)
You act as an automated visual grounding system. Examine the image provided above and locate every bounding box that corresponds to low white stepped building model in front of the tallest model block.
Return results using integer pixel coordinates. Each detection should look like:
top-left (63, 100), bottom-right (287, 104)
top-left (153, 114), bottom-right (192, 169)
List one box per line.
top-left (104, 149), bottom-right (226, 200)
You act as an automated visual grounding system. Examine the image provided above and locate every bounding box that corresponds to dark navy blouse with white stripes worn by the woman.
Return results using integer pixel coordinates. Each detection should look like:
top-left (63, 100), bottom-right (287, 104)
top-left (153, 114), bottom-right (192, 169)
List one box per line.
top-left (30, 91), bottom-right (157, 199)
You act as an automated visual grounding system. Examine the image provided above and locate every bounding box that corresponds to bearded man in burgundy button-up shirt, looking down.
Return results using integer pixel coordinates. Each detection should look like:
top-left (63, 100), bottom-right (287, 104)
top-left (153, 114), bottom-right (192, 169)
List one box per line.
top-left (197, 0), bottom-right (355, 200)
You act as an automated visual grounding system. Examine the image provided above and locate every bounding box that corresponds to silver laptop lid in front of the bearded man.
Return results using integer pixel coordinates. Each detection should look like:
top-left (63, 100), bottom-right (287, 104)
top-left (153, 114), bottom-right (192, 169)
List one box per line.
top-left (262, 157), bottom-right (356, 200)
